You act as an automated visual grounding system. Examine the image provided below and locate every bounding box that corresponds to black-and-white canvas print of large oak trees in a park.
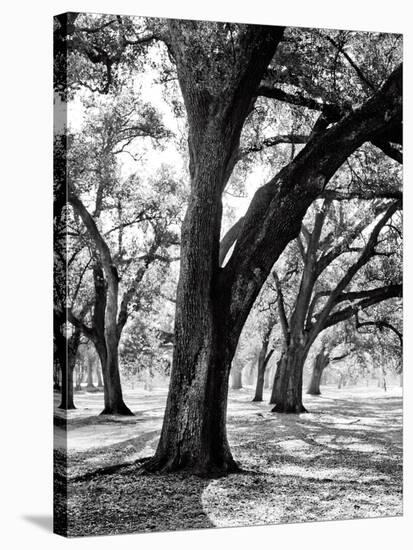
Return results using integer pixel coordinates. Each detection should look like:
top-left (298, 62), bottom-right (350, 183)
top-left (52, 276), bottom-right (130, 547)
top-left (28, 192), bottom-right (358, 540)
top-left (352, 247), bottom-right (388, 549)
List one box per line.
top-left (53, 13), bottom-right (403, 537)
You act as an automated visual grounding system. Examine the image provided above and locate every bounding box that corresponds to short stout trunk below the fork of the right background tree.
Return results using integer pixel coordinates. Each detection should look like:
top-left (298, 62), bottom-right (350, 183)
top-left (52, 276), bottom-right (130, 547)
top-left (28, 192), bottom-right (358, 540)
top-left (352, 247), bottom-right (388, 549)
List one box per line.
top-left (271, 343), bottom-right (307, 413)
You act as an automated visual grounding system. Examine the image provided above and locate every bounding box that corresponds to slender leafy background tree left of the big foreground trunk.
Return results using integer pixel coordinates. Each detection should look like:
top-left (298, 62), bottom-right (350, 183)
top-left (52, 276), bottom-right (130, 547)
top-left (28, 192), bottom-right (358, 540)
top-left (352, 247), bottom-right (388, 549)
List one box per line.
top-left (68, 95), bottom-right (181, 415)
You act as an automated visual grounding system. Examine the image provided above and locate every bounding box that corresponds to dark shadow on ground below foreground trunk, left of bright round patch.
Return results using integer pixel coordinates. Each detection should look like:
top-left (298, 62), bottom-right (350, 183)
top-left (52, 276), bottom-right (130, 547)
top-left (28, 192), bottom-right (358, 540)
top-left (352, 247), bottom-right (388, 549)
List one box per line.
top-left (67, 467), bottom-right (215, 537)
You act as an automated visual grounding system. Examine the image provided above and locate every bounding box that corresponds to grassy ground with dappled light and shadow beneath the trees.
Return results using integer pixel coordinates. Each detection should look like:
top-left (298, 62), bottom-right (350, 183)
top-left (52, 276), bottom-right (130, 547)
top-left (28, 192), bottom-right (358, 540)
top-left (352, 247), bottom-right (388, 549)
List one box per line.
top-left (55, 388), bottom-right (402, 536)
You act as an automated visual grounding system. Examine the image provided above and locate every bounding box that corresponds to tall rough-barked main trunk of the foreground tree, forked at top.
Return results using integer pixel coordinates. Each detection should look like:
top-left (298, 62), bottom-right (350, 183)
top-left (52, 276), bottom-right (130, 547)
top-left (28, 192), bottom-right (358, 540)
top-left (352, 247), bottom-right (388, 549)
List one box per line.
top-left (144, 22), bottom-right (283, 475)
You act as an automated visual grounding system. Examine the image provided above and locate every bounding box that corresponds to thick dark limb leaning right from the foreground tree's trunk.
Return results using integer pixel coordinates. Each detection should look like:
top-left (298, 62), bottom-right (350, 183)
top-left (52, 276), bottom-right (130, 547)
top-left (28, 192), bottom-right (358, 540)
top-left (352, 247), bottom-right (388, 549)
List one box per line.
top-left (219, 65), bottom-right (402, 342)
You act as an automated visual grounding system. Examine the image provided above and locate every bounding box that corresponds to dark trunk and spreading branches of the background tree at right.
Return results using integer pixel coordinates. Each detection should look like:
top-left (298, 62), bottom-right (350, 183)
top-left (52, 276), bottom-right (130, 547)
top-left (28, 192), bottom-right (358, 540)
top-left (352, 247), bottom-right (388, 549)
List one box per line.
top-left (271, 200), bottom-right (402, 413)
